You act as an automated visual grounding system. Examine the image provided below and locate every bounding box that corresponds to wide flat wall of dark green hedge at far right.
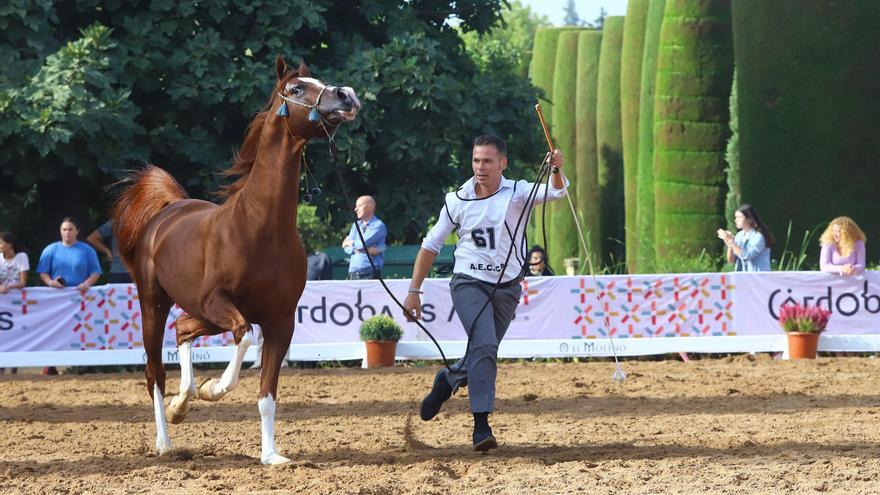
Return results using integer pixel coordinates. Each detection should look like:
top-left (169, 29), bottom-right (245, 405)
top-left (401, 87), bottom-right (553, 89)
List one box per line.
top-left (733, 0), bottom-right (880, 260)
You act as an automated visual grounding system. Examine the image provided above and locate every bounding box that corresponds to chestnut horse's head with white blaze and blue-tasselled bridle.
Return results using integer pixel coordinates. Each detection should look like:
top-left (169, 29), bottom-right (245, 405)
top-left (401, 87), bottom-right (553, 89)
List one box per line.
top-left (275, 56), bottom-right (361, 139)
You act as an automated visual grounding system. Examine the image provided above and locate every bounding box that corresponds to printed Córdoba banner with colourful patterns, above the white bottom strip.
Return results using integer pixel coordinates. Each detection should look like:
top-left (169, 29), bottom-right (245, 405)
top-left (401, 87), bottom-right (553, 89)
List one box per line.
top-left (0, 272), bottom-right (880, 352)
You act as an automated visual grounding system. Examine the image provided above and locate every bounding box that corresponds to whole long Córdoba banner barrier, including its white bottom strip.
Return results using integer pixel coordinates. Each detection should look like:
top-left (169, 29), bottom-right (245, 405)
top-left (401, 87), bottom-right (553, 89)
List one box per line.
top-left (0, 272), bottom-right (880, 366)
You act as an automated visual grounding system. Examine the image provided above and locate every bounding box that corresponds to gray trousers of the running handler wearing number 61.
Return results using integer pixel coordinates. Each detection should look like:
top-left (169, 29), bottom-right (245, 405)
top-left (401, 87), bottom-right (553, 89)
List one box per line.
top-left (441, 274), bottom-right (522, 413)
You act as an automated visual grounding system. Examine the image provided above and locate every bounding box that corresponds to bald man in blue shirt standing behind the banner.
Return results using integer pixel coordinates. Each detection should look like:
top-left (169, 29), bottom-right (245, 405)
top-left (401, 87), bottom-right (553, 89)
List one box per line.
top-left (342, 196), bottom-right (388, 280)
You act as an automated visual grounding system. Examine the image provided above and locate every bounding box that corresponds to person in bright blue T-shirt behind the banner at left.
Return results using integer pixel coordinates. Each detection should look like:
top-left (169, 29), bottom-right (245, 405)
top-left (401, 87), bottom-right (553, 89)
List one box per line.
top-left (37, 217), bottom-right (101, 291)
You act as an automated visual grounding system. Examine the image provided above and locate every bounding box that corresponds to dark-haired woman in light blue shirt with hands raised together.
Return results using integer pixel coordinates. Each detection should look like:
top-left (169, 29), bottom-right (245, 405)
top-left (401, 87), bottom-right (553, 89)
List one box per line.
top-left (718, 204), bottom-right (775, 272)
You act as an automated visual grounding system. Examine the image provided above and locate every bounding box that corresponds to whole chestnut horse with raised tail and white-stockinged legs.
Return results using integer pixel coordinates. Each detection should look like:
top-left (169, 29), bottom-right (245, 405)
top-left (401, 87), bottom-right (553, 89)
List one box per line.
top-left (113, 57), bottom-right (360, 464)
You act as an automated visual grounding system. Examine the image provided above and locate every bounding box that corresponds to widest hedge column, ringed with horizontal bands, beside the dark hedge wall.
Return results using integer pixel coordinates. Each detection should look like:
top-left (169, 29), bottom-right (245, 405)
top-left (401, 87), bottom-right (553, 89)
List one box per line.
top-left (654, 0), bottom-right (733, 261)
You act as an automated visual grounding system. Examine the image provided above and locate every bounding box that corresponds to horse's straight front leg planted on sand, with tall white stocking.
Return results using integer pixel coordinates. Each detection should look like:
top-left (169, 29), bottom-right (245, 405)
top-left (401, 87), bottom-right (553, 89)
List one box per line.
top-left (257, 321), bottom-right (293, 464)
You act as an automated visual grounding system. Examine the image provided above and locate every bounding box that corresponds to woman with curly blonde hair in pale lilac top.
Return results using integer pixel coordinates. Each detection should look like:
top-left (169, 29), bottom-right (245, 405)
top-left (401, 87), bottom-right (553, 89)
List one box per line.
top-left (819, 217), bottom-right (865, 277)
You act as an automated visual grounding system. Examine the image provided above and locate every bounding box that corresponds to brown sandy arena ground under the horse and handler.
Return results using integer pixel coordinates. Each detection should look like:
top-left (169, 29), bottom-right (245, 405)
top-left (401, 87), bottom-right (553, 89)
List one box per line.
top-left (0, 356), bottom-right (880, 495)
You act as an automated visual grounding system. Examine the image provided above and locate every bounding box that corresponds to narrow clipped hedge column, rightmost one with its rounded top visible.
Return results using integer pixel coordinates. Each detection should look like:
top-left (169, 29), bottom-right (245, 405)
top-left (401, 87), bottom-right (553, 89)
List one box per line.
top-left (596, 17), bottom-right (625, 264)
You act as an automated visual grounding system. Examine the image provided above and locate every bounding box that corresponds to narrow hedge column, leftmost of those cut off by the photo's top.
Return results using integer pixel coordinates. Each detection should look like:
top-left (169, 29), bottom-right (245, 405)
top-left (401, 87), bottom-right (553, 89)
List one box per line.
top-left (620, 0), bottom-right (650, 273)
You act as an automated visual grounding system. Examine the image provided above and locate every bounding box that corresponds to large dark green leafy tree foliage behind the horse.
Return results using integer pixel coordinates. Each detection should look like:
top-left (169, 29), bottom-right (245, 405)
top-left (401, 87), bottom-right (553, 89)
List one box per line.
top-left (0, 0), bottom-right (541, 249)
